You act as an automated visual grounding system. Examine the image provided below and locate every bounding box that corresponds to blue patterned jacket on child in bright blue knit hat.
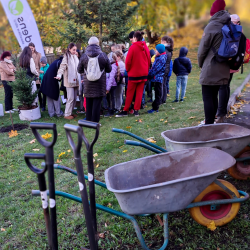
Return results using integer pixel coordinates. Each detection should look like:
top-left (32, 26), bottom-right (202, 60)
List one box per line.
top-left (148, 53), bottom-right (168, 83)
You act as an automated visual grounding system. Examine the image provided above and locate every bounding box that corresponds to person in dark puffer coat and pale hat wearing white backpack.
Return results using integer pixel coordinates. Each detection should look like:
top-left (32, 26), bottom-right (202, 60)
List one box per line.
top-left (78, 37), bottom-right (112, 122)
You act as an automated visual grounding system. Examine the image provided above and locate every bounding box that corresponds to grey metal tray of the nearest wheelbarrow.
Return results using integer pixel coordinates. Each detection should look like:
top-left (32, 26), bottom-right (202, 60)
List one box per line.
top-left (105, 148), bottom-right (235, 215)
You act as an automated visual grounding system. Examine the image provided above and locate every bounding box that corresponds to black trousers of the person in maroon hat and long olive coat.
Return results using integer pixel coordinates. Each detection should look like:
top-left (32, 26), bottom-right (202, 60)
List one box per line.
top-left (202, 85), bottom-right (220, 124)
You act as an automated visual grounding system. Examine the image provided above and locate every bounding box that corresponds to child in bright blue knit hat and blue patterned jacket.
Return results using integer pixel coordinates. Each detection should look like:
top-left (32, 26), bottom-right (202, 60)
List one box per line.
top-left (148, 44), bottom-right (167, 114)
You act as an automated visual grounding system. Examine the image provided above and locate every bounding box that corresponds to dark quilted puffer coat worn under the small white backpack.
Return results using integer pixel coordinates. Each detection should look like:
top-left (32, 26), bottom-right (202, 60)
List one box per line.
top-left (78, 44), bottom-right (112, 98)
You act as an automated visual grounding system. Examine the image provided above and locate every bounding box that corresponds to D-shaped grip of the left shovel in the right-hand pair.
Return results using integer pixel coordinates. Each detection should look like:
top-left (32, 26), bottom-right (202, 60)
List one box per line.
top-left (64, 124), bottom-right (83, 157)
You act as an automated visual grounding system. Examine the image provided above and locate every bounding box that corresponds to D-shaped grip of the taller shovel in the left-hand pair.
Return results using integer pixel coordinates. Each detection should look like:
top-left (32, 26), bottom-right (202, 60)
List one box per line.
top-left (30, 122), bottom-right (57, 148)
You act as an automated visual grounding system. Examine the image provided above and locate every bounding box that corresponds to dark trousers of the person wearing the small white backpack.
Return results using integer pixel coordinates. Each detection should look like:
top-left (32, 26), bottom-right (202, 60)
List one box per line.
top-left (86, 97), bottom-right (102, 122)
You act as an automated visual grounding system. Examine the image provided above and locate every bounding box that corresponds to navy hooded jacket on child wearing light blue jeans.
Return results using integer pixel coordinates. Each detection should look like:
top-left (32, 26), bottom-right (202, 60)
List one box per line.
top-left (173, 47), bottom-right (192, 76)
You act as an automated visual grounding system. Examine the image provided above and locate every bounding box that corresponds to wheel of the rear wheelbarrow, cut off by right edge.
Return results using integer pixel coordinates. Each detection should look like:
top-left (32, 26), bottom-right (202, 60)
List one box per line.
top-left (227, 146), bottom-right (250, 180)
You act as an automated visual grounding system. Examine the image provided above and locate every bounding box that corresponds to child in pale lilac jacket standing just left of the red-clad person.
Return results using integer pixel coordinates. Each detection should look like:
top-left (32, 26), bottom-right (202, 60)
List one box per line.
top-left (104, 53), bottom-right (120, 117)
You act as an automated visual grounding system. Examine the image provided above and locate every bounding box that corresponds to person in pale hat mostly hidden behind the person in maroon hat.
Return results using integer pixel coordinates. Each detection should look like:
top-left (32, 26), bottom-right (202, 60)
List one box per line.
top-left (216, 14), bottom-right (246, 123)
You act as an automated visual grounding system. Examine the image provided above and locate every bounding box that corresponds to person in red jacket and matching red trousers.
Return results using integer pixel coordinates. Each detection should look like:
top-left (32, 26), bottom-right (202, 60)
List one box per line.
top-left (116, 31), bottom-right (151, 117)
